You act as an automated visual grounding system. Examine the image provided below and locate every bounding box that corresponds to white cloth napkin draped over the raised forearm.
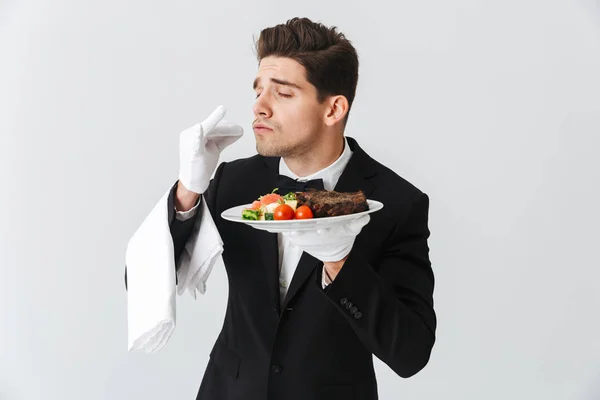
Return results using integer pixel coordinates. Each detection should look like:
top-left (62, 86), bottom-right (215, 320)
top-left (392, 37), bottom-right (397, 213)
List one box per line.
top-left (125, 189), bottom-right (223, 353)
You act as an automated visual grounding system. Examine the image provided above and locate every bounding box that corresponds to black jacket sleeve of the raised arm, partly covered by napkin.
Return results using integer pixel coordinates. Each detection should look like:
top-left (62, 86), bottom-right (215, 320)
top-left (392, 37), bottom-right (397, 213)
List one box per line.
top-left (125, 162), bottom-right (225, 290)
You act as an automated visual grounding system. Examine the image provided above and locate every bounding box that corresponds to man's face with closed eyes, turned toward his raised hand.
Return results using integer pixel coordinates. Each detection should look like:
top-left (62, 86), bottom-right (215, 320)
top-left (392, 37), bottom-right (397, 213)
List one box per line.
top-left (253, 57), bottom-right (328, 158)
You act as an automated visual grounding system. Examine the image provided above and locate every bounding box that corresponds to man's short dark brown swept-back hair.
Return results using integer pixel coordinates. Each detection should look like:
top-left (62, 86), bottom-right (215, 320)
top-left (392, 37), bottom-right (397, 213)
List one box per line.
top-left (256, 18), bottom-right (358, 119)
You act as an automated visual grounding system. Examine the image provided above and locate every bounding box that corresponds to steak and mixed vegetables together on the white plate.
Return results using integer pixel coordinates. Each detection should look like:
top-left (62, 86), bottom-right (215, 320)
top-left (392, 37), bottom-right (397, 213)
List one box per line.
top-left (242, 189), bottom-right (369, 221)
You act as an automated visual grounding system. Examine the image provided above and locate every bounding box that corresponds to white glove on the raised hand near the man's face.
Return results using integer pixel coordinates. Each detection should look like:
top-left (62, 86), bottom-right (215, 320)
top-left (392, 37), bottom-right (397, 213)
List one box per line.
top-left (179, 106), bottom-right (244, 194)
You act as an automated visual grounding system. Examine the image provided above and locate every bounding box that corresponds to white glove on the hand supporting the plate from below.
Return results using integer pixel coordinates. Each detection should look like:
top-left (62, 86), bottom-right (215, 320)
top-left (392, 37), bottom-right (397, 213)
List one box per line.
top-left (281, 214), bottom-right (371, 262)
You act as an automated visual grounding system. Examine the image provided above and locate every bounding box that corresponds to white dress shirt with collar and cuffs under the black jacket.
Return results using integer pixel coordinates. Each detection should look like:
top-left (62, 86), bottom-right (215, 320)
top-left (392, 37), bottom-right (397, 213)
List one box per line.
top-left (176, 138), bottom-right (352, 303)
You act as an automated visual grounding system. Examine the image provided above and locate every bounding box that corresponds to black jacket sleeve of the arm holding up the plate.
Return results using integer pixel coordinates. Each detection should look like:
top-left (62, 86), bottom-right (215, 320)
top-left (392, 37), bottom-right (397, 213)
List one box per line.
top-left (323, 193), bottom-right (436, 378)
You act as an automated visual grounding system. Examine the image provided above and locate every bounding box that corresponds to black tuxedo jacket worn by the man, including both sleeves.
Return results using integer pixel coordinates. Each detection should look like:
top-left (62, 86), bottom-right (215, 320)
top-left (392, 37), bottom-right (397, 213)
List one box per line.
top-left (126, 138), bottom-right (436, 400)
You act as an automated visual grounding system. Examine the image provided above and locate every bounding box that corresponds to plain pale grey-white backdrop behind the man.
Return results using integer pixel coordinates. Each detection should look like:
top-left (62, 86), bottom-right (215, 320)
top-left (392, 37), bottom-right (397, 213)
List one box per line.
top-left (0, 0), bottom-right (600, 400)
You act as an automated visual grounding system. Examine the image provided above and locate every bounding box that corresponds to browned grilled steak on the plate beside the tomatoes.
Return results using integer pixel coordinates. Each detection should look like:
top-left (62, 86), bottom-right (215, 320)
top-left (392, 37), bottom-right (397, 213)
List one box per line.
top-left (296, 190), bottom-right (369, 218)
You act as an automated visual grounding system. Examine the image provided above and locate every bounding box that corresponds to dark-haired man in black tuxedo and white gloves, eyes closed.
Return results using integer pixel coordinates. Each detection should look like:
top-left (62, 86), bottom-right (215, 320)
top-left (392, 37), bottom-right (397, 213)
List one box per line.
top-left (126, 18), bottom-right (436, 400)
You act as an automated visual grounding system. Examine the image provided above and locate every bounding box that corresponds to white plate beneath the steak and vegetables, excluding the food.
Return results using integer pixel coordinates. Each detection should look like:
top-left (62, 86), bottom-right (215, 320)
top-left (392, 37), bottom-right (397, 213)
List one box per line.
top-left (221, 200), bottom-right (383, 233)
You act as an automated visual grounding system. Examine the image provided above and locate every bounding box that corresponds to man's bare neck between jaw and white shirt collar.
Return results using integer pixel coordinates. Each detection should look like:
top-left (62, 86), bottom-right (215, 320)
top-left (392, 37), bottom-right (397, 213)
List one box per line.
top-left (283, 135), bottom-right (344, 177)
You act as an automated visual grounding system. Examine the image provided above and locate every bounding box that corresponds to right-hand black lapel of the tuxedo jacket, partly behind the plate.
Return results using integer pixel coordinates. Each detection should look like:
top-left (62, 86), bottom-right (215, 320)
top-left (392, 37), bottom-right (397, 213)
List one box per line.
top-left (281, 137), bottom-right (375, 310)
